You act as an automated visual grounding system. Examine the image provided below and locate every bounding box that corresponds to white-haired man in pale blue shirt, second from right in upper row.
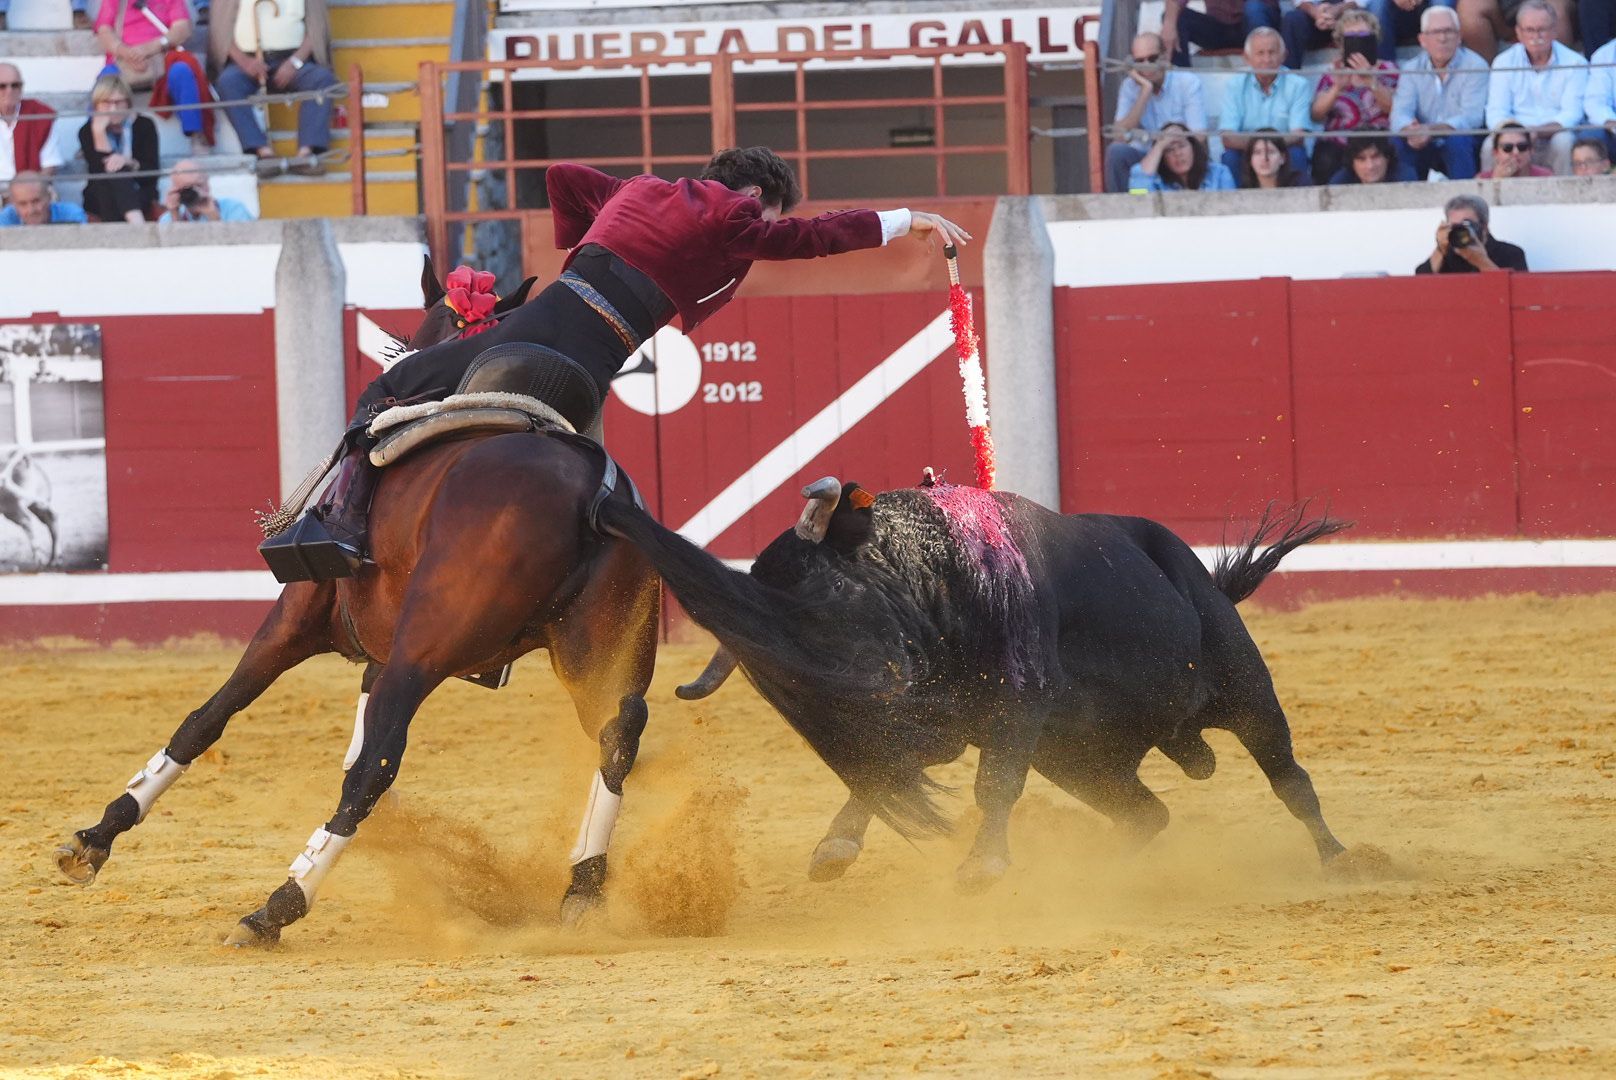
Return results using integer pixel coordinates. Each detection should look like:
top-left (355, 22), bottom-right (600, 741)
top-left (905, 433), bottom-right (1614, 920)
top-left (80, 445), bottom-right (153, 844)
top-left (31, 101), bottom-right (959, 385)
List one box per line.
top-left (1482, 0), bottom-right (1589, 176)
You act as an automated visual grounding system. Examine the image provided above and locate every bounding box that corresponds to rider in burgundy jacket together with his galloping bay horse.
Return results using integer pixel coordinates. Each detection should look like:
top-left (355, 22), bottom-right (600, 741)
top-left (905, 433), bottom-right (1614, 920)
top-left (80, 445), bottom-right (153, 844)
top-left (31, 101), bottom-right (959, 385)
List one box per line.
top-left (57, 147), bottom-right (970, 944)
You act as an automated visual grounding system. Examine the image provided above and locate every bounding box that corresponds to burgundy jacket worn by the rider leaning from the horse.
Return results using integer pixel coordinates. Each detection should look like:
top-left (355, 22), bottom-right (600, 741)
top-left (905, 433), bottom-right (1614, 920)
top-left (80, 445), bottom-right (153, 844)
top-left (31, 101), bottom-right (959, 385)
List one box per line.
top-left (545, 165), bottom-right (881, 331)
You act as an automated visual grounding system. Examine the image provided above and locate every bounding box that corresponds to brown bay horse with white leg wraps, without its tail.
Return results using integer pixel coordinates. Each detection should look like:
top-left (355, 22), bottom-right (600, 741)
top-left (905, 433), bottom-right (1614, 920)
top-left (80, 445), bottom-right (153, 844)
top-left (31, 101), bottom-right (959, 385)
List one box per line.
top-left (57, 262), bottom-right (661, 946)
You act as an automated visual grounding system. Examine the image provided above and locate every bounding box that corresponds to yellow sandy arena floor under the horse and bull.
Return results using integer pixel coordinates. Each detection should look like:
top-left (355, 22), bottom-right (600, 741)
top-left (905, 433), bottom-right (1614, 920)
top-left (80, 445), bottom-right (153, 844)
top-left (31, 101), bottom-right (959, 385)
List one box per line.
top-left (0, 593), bottom-right (1616, 1080)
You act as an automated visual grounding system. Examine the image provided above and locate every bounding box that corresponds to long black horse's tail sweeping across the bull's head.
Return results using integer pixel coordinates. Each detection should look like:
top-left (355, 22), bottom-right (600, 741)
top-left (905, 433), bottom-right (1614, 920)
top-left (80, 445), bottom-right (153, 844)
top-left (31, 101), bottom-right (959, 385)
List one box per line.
top-left (600, 498), bottom-right (950, 836)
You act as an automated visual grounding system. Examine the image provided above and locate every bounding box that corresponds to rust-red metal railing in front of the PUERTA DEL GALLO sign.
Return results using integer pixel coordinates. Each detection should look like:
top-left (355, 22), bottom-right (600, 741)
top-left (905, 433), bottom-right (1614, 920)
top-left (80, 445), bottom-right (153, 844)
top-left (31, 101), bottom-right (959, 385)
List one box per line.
top-left (419, 44), bottom-right (1033, 265)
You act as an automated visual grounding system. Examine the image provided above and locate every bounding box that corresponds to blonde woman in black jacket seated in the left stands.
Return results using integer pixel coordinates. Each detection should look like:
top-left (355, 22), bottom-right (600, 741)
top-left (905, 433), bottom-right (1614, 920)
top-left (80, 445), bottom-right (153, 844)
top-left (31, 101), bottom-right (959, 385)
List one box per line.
top-left (79, 74), bottom-right (158, 221)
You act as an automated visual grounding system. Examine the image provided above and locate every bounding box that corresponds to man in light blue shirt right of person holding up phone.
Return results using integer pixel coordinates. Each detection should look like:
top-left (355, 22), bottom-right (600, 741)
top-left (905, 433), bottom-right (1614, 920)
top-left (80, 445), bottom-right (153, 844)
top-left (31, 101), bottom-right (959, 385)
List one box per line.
top-left (1391, 8), bottom-right (1488, 179)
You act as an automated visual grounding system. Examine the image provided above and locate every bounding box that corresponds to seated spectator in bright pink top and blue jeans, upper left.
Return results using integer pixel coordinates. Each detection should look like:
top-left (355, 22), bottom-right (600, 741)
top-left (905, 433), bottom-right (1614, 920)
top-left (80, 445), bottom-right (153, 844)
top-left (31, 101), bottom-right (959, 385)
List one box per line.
top-left (95, 0), bottom-right (208, 154)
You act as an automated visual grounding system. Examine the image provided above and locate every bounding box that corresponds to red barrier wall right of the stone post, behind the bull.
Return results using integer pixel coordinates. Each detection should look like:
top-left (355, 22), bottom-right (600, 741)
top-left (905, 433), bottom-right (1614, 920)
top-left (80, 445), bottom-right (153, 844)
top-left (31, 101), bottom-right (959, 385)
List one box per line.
top-left (1060, 273), bottom-right (1616, 543)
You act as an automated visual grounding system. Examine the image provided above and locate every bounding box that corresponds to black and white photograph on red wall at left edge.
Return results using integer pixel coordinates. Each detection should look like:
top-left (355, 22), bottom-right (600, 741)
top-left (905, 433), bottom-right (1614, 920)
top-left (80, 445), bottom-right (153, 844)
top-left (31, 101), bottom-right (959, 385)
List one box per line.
top-left (0, 323), bottom-right (107, 574)
